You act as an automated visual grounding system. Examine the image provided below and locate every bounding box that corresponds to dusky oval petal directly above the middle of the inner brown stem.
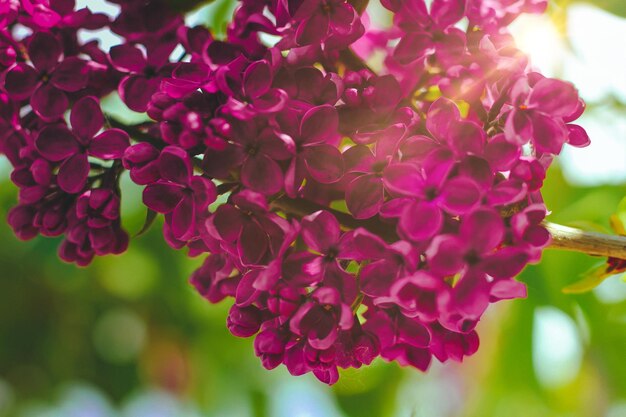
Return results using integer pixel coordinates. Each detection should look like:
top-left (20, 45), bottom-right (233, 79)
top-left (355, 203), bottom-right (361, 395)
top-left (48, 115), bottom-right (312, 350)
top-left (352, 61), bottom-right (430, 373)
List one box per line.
top-left (346, 175), bottom-right (384, 219)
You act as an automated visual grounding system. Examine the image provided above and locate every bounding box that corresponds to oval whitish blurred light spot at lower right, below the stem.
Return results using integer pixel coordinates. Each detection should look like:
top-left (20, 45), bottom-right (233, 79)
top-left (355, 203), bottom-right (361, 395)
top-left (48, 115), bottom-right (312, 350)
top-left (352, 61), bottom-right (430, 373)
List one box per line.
top-left (533, 307), bottom-right (583, 388)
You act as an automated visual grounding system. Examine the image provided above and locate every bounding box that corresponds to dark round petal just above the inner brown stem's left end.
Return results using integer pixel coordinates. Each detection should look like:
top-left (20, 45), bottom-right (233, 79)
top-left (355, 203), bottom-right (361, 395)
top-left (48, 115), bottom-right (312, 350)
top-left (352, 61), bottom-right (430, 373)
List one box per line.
top-left (241, 155), bottom-right (283, 195)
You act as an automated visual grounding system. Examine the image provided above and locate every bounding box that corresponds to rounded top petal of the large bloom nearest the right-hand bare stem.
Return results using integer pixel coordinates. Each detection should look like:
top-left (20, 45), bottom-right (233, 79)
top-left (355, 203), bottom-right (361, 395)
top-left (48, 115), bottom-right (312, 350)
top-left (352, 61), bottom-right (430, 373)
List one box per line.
top-left (459, 207), bottom-right (504, 253)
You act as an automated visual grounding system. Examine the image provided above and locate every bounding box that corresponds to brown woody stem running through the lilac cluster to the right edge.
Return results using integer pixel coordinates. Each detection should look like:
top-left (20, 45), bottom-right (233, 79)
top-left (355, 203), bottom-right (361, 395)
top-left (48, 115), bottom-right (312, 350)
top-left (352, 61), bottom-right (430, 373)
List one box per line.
top-left (272, 197), bottom-right (626, 260)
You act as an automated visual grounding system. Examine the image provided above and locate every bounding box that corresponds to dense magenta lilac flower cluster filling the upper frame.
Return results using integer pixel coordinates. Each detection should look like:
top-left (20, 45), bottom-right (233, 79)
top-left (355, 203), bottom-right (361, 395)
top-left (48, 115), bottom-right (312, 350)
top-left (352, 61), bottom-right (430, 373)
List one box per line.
top-left (0, 0), bottom-right (589, 384)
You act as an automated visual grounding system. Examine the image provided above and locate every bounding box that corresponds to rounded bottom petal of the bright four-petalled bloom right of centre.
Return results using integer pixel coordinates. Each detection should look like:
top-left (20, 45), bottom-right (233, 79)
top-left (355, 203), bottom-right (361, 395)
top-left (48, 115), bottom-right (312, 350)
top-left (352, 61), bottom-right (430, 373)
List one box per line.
top-left (398, 202), bottom-right (443, 242)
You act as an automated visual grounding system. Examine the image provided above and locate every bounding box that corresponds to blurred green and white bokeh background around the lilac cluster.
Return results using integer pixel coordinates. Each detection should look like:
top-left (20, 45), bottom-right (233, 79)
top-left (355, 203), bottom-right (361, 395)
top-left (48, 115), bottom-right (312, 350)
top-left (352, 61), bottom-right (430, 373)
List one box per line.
top-left (0, 0), bottom-right (626, 417)
